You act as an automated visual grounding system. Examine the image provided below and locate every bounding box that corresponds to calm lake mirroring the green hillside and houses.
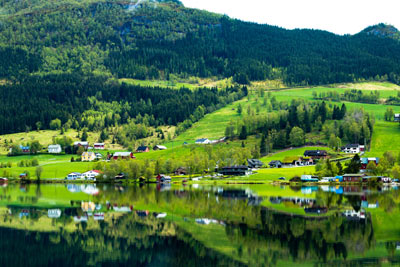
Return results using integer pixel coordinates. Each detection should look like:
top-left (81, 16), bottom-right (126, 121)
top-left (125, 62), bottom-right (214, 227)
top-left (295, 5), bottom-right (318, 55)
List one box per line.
top-left (0, 184), bottom-right (400, 266)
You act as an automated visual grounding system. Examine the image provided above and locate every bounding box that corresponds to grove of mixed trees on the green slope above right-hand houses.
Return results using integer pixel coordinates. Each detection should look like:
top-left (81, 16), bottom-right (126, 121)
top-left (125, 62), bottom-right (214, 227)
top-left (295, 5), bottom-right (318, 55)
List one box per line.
top-left (225, 97), bottom-right (374, 154)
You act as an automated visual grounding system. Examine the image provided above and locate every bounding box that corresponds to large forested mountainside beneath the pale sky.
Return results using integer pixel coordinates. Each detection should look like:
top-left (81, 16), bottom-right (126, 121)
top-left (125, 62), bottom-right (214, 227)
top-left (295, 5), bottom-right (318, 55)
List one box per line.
top-left (0, 0), bottom-right (400, 85)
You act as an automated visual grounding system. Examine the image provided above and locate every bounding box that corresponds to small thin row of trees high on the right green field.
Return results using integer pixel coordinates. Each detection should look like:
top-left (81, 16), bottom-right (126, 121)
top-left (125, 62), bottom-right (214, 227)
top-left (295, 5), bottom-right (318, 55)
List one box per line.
top-left (312, 89), bottom-right (380, 104)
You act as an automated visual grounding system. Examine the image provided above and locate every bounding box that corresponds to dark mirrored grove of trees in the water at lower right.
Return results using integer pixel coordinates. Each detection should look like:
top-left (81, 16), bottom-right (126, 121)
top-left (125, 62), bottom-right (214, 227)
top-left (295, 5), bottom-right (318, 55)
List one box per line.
top-left (226, 209), bottom-right (374, 264)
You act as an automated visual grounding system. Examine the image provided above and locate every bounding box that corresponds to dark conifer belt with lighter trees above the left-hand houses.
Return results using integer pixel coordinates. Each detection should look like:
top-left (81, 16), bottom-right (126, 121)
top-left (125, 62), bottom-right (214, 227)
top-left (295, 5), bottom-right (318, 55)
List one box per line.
top-left (0, 73), bottom-right (247, 134)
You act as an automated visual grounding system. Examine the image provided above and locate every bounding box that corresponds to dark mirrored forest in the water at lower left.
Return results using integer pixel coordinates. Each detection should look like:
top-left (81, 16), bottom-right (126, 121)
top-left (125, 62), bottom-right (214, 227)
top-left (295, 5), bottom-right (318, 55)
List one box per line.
top-left (0, 214), bottom-right (242, 266)
